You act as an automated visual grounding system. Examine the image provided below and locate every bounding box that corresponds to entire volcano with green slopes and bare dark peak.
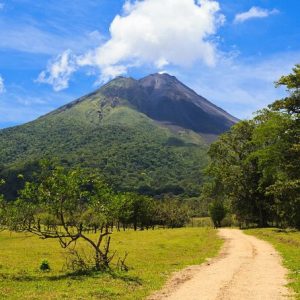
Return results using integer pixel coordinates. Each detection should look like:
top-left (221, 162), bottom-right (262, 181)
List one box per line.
top-left (0, 74), bottom-right (236, 198)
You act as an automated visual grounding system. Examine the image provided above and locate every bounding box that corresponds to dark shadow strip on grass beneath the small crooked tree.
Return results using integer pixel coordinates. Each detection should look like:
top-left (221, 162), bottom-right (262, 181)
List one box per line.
top-left (0, 270), bottom-right (142, 285)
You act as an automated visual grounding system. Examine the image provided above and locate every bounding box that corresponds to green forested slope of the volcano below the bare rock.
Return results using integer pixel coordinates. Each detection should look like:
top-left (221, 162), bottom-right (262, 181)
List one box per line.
top-left (0, 93), bottom-right (207, 199)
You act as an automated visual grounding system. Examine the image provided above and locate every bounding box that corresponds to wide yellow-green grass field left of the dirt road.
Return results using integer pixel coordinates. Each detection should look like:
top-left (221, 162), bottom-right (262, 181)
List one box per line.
top-left (0, 228), bottom-right (222, 299)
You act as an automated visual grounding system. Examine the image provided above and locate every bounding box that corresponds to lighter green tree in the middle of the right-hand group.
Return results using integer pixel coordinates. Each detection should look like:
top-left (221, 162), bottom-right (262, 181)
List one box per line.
top-left (251, 109), bottom-right (290, 226)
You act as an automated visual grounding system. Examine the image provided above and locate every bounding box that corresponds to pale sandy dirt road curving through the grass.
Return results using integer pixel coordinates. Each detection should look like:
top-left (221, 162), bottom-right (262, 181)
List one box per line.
top-left (149, 229), bottom-right (291, 300)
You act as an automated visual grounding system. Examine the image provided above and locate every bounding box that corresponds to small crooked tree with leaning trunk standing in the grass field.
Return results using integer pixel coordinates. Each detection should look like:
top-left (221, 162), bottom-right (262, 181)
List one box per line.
top-left (7, 165), bottom-right (116, 270)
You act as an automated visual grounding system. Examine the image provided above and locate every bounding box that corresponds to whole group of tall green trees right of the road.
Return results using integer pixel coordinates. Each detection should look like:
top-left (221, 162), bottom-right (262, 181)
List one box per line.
top-left (202, 65), bottom-right (300, 229)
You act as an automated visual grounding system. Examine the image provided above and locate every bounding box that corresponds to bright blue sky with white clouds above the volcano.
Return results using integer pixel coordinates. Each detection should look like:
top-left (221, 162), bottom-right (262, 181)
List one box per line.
top-left (0, 0), bottom-right (300, 128)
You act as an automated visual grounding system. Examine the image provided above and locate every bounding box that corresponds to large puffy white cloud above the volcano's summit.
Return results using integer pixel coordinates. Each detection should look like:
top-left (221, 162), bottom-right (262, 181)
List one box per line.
top-left (78, 0), bottom-right (225, 81)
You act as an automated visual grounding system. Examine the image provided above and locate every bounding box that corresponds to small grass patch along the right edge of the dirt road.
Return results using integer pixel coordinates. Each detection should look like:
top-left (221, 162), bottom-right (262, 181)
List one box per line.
top-left (245, 228), bottom-right (300, 299)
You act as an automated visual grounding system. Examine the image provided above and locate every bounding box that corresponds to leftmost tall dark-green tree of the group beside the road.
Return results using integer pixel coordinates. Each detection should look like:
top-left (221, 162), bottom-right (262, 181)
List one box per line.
top-left (207, 121), bottom-right (267, 226)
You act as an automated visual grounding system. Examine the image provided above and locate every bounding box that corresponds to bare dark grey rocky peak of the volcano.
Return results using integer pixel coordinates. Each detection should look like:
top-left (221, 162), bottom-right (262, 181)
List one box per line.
top-left (100, 74), bottom-right (237, 134)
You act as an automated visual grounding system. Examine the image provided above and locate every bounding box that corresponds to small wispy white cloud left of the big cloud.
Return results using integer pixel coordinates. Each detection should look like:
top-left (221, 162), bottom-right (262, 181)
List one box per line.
top-left (36, 50), bottom-right (77, 91)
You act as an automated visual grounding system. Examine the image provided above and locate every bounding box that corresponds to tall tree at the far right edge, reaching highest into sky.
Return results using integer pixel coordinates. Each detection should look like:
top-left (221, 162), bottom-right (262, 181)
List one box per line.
top-left (267, 64), bottom-right (300, 228)
